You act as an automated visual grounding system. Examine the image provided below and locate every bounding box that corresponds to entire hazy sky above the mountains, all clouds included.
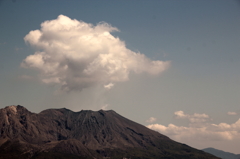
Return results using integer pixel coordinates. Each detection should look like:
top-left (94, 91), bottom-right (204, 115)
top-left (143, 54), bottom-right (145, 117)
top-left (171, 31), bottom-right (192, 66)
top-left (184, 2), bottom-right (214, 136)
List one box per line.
top-left (0, 0), bottom-right (240, 153)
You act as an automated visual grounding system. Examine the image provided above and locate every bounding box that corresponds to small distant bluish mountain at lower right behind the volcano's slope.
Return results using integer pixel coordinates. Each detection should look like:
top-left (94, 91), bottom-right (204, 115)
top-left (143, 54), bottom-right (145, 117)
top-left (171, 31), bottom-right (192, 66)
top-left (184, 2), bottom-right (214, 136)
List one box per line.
top-left (203, 148), bottom-right (240, 159)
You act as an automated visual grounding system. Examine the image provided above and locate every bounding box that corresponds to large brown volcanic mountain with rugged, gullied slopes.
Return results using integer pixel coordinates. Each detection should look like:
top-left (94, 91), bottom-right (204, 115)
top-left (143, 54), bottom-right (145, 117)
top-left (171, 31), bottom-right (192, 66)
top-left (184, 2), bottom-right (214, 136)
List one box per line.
top-left (0, 106), bottom-right (217, 159)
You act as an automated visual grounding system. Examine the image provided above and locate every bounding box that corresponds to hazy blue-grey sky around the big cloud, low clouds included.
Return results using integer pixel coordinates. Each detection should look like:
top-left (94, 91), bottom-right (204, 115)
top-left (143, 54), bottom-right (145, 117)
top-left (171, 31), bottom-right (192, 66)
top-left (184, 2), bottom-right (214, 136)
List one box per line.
top-left (0, 0), bottom-right (240, 153)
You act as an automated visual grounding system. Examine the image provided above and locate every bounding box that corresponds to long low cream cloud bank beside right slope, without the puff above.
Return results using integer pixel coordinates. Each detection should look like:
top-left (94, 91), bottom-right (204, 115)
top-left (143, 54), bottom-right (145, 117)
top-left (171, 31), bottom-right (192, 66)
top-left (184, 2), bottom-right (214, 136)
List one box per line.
top-left (147, 120), bottom-right (240, 143)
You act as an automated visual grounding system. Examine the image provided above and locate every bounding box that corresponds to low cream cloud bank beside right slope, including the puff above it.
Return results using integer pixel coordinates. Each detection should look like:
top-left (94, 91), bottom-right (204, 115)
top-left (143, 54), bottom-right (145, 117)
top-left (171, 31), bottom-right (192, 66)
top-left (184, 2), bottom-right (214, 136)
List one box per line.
top-left (147, 111), bottom-right (240, 143)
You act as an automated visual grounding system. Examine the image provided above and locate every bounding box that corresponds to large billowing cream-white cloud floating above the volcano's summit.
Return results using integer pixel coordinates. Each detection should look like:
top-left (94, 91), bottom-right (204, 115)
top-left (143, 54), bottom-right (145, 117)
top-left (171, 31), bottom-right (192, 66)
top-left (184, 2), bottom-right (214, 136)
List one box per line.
top-left (21, 15), bottom-right (170, 91)
